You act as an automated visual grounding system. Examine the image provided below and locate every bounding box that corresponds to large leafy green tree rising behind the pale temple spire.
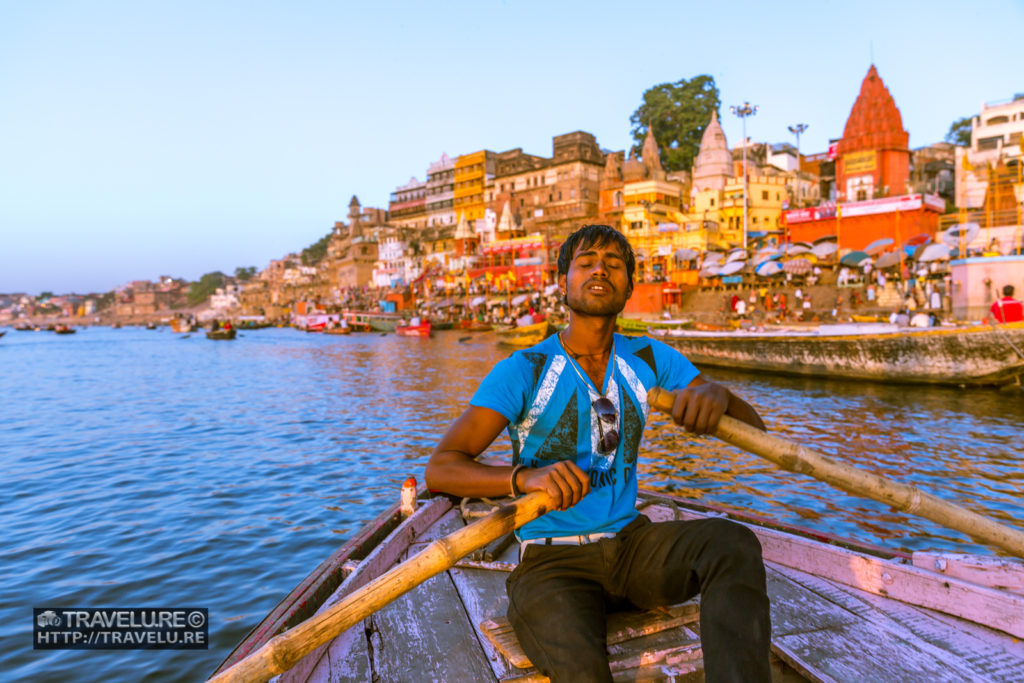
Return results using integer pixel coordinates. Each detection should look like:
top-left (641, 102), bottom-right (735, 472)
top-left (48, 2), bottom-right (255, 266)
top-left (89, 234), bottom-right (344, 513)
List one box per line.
top-left (630, 75), bottom-right (722, 172)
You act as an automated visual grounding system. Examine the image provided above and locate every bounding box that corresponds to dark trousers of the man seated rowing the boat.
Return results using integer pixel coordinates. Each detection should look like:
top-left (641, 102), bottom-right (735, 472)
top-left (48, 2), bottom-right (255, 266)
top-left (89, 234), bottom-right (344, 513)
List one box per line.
top-left (507, 515), bottom-right (771, 683)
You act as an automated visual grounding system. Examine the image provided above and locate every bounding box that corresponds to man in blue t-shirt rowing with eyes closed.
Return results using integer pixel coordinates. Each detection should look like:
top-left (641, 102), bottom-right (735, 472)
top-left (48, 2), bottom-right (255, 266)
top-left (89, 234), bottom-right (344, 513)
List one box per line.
top-left (426, 225), bottom-right (770, 682)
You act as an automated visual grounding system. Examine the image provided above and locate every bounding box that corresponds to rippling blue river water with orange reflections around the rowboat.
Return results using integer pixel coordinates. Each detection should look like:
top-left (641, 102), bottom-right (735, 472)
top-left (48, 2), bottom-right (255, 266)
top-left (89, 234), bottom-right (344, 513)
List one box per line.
top-left (0, 328), bottom-right (1024, 681)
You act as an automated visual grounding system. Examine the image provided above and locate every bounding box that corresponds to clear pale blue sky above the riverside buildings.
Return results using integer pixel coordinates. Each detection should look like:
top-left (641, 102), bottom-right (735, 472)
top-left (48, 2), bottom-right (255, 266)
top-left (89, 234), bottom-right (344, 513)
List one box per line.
top-left (0, 0), bottom-right (1024, 293)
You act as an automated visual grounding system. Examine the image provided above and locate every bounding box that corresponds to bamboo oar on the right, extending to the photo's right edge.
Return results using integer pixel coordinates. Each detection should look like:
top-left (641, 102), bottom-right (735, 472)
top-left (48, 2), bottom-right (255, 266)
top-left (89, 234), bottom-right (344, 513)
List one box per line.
top-left (647, 387), bottom-right (1024, 557)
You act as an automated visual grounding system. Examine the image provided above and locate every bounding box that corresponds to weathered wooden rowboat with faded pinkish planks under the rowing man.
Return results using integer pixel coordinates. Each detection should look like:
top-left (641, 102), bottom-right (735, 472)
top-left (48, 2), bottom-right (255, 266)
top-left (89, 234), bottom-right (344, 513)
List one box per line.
top-left (217, 485), bottom-right (1024, 683)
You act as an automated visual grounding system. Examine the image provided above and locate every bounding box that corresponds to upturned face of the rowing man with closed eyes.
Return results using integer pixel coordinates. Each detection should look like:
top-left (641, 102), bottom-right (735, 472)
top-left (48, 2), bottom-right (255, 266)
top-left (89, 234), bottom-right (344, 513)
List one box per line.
top-left (558, 242), bottom-right (633, 315)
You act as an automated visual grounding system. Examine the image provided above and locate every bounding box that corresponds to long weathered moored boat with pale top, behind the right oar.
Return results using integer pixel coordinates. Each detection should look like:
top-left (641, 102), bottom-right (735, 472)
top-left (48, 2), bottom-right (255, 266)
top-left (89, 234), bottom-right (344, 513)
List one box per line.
top-left (662, 323), bottom-right (1024, 386)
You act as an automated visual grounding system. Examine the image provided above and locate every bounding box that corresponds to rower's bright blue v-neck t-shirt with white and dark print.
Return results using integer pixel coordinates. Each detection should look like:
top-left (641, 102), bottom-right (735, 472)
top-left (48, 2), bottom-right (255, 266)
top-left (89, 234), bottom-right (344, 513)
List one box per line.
top-left (469, 335), bottom-right (698, 540)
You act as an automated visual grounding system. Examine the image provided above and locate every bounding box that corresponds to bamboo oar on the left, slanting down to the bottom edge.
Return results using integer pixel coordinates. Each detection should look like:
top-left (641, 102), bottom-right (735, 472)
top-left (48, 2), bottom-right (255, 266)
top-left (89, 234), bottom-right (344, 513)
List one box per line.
top-left (210, 492), bottom-right (553, 683)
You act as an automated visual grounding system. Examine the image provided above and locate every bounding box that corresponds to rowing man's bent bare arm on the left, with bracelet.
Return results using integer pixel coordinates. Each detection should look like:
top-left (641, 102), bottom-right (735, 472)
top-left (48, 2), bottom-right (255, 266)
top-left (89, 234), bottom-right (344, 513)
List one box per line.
top-left (425, 405), bottom-right (590, 510)
